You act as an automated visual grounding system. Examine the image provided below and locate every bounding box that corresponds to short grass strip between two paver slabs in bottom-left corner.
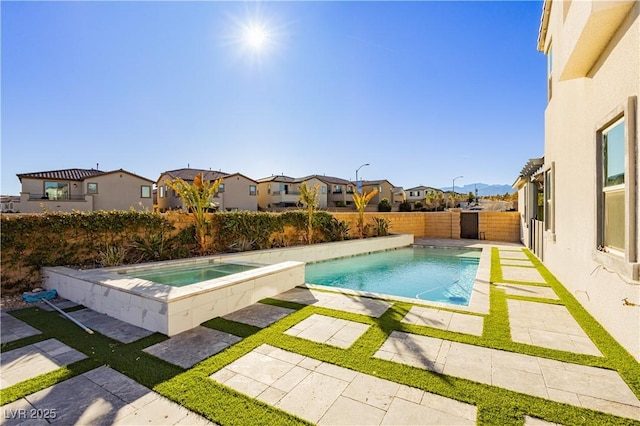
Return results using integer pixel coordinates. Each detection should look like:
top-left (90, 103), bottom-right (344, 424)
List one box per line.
top-left (0, 358), bottom-right (100, 405)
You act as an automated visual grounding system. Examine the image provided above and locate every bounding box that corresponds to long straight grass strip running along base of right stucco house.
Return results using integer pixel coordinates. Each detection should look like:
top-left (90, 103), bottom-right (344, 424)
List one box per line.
top-left (525, 251), bottom-right (640, 398)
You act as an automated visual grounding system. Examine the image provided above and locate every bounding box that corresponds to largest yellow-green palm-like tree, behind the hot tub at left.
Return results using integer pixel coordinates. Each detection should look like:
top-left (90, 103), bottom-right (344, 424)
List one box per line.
top-left (166, 173), bottom-right (222, 254)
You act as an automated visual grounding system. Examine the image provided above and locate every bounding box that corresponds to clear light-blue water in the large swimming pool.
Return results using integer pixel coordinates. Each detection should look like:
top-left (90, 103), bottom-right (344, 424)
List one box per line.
top-left (305, 246), bottom-right (482, 306)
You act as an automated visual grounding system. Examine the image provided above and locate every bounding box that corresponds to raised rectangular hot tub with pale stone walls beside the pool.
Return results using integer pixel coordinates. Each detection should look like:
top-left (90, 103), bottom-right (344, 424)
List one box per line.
top-left (42, 256), bottom-right (304, 336)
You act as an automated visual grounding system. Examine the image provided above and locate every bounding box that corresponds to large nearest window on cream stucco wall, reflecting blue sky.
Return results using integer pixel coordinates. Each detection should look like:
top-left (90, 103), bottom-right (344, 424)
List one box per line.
top-left (602, 118), bottom-right (626, 252)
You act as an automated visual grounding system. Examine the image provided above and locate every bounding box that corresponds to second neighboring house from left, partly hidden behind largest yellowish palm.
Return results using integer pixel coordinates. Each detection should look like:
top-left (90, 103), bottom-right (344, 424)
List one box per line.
top-left (157, 168), bottom-right (258, 212)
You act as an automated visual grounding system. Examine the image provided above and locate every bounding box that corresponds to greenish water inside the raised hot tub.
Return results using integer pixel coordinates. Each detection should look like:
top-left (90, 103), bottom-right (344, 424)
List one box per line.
top-left (122, 263), bottom-right (257, 287)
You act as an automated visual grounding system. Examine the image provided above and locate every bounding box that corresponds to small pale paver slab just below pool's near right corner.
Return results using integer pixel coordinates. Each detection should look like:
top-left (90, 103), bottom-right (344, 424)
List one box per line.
top-left (402, 306), bottom-right (484, 336)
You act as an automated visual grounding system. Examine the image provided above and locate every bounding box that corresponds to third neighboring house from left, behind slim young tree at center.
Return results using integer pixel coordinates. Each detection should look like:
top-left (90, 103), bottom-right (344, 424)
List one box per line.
top-left (258, 175), bottom-right (329, 210)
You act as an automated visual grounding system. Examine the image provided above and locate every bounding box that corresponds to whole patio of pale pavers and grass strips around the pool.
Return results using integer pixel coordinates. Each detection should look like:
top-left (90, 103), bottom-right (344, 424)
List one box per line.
top-left (0, 240), bottom-right (640, 425)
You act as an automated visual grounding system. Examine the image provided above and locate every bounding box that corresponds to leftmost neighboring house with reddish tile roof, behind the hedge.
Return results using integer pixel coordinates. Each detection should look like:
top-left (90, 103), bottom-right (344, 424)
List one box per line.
top-left (17, 169), bottom-right (154, 213)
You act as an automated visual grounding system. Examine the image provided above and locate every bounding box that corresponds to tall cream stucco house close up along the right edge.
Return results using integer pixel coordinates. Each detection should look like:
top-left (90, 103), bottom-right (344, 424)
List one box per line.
top-left (525, 0), bottom-right (640, 360)
